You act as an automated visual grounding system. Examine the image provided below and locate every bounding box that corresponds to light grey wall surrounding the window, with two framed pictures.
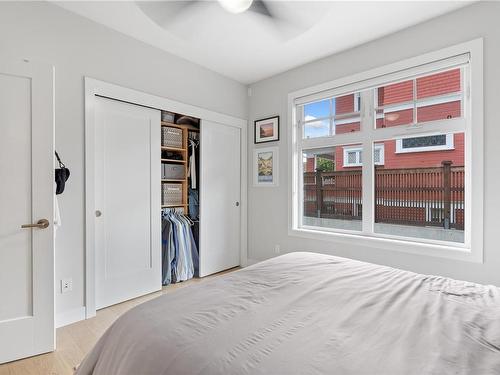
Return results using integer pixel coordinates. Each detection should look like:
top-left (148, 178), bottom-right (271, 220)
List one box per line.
top-left (248, 2), bottom-right (500, 286)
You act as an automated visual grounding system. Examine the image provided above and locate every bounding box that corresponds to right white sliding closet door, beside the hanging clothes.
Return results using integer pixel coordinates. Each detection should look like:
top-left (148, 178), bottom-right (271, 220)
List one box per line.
top-left (200, 121), bottom-right (241, 276)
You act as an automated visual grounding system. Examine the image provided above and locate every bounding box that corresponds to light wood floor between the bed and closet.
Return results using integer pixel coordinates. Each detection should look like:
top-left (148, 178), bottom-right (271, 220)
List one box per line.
top-left (0, 267), bottom-right (239, 375)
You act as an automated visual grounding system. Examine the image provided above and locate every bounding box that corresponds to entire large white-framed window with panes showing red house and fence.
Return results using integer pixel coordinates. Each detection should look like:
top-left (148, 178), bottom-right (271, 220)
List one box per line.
top-left (290, 42), bottom-right (483, 261)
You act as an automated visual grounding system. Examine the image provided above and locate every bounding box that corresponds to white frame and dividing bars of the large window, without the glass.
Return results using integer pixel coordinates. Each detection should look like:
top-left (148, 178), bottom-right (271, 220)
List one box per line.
top-left (288, 38), bottom-right (484, 263)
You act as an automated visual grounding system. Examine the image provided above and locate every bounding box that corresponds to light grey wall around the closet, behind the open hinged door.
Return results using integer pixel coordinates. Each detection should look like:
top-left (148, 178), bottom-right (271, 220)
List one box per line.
top-left (0, 1), bottom-right (247, 321)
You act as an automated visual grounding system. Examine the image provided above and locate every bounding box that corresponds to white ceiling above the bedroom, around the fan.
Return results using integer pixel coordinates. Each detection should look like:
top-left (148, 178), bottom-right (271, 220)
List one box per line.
top-left (55, 1), bottom-right (471, 84)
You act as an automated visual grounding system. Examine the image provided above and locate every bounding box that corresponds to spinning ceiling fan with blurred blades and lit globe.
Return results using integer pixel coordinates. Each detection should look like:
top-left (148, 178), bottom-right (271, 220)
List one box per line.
top-left (136, 0), bottom-right (312, 39)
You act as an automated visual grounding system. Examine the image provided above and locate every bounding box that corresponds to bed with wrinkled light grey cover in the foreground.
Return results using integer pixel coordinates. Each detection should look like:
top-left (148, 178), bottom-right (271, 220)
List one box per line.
top-left (76, 252), bottom-right (500, 375)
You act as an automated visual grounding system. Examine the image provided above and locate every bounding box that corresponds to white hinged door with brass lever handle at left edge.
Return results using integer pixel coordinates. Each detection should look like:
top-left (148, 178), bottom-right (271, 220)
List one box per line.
top-left (0, 60), bottom-right (55, 363)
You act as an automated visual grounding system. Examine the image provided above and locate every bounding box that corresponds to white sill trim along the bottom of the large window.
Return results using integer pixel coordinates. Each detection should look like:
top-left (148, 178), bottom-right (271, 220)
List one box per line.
top-left (288, 227), bottom-right (483, 263)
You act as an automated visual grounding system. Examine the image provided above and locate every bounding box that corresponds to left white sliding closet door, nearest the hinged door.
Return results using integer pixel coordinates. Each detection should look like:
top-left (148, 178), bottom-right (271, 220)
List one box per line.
top-left (94, 97), bottom-right (161, 309)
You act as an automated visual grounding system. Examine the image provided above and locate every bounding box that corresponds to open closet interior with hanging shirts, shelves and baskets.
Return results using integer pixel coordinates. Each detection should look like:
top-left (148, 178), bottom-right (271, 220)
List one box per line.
top-left (161, 111), bottom-right (200, 285)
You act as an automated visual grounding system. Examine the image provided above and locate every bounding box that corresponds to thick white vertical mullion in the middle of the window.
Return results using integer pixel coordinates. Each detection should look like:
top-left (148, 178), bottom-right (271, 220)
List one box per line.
top-left (361, 90), bottom-right (375, 234)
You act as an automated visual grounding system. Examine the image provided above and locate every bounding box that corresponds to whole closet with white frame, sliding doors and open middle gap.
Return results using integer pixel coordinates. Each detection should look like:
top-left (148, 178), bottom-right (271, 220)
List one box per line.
top-left (89, 79), bottom-right (246, 317)
